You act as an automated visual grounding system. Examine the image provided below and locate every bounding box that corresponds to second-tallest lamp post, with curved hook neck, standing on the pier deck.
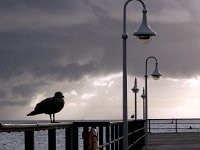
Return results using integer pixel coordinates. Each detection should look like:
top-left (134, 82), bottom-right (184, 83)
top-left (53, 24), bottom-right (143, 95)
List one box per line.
top-left (145, 56), bottom-right (162, 146)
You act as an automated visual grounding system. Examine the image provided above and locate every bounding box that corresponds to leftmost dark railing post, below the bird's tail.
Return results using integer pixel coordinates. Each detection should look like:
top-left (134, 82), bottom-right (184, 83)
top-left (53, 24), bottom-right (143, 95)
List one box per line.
top-left (24, 130), bottom-right (34, 150)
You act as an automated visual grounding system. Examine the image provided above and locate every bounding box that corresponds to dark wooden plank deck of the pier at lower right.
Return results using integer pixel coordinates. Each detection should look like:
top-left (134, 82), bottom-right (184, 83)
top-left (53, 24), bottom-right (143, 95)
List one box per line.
top-left (142, 133), bottom-right (200, 150)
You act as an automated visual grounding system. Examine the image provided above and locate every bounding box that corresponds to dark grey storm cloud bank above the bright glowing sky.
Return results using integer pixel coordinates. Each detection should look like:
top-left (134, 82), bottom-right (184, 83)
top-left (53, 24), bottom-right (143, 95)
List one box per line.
top-left (0, 0), bottom-right (200, 109)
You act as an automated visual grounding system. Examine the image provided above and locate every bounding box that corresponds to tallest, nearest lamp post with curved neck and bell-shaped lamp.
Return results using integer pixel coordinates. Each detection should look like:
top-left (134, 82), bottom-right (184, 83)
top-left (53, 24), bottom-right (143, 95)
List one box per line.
top-left (122, 0), bottom-right (156, 150)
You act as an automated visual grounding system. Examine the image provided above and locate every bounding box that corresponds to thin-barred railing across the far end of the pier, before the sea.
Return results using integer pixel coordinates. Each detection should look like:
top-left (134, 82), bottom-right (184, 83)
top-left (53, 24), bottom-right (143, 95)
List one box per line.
top-left (148, 118), bottom-right (200, 133)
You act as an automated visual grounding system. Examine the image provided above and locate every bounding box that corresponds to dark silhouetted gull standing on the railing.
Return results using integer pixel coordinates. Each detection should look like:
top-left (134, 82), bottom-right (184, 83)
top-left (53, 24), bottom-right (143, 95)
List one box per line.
top-left (27, 92), bottom-right (65, 123)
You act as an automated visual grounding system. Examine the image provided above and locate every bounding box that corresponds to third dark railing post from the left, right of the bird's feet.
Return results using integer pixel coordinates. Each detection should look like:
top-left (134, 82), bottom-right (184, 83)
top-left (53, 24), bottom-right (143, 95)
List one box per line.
top-left (65, 128), bottom-right (73, 150)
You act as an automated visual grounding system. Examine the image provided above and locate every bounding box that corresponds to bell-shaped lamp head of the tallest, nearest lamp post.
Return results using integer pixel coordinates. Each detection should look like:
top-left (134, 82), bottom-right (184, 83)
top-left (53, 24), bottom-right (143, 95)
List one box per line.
top-left (133, 9), bottom-right (156, 44)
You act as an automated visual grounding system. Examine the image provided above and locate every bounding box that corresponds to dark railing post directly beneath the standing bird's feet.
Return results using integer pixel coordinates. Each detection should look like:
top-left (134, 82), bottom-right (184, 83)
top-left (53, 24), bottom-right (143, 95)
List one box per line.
top-left (48, 129), bottom-right (56, 150)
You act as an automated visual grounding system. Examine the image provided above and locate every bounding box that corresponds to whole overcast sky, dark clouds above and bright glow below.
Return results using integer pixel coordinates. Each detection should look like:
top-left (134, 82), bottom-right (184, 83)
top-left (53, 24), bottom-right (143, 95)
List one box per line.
top-left (0, 0), bottom-right (200, 120)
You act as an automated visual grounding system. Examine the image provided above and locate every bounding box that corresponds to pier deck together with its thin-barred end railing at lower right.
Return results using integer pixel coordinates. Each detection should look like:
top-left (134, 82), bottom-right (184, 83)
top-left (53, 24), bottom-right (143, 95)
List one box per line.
top-left (142, 119), bottom-right (200, 150)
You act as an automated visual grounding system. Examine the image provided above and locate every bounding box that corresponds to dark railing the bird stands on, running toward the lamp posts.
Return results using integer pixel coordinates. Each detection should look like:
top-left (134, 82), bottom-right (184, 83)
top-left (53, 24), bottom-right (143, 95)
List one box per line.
top-left (0, 120), bottom-right (145, 150)
